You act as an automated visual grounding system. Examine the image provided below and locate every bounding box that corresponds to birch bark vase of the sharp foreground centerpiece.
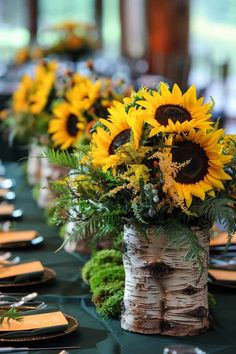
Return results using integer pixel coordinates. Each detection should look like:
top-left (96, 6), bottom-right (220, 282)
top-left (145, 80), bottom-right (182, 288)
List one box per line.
top-left (121, 227), bottom-right (209, 336)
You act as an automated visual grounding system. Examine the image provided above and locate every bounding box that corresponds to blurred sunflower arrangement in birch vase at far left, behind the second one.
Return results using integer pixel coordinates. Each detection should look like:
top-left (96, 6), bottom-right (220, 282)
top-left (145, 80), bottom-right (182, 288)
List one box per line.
top-left (1, 61), bottom-right (58, 184)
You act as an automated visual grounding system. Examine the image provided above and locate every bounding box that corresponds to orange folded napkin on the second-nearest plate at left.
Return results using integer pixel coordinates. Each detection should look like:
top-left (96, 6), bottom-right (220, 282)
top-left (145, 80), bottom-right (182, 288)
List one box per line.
top-left (0, 261), bottom-right (44, 284)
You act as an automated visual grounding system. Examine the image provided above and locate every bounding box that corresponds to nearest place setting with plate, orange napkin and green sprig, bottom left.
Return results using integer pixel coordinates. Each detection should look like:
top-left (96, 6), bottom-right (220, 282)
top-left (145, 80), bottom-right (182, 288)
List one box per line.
top-left (0, 292), bottom-right (79, 346)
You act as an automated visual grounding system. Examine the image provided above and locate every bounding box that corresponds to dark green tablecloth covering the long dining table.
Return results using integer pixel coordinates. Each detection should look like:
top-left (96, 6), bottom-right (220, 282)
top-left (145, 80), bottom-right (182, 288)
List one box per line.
top-left (1, 164), bottom-right (236, 354)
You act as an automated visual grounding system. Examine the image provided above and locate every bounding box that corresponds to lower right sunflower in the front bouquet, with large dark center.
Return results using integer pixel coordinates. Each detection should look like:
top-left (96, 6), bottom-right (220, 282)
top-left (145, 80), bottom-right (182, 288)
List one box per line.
top-left (162, 129), bottom-right (232, 207)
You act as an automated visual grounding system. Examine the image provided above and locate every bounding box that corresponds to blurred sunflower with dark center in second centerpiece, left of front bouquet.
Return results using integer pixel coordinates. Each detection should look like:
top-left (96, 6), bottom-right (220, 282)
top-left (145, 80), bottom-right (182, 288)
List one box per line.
top-left (48, 102), bottom-right (86, 150)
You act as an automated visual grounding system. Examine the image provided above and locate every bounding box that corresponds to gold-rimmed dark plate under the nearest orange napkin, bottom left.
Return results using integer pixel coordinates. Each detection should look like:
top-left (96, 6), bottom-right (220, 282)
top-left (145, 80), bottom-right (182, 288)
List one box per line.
top-left (0, 308), bottom-right (79, 342)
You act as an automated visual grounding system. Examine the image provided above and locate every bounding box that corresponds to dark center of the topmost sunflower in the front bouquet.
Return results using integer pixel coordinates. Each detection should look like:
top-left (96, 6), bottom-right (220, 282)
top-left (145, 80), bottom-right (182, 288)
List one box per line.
top-left (155, 104), bottom-right (192, 127)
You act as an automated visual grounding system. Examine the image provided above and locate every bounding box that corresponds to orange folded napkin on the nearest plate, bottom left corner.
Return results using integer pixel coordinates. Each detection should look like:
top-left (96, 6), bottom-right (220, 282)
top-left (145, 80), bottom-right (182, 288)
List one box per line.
top-left (0, 305), bottom-right (68, 338)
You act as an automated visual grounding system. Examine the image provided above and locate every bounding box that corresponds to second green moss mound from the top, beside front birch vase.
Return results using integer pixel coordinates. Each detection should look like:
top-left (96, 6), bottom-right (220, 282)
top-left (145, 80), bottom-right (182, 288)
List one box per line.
top-left (90, 265), bottom-right (125, 292)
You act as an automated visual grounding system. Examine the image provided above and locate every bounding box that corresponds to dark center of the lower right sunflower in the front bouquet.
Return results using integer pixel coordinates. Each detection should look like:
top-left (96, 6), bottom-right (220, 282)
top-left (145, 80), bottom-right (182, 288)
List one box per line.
top-left (171, 141), bottom-right (208, 184)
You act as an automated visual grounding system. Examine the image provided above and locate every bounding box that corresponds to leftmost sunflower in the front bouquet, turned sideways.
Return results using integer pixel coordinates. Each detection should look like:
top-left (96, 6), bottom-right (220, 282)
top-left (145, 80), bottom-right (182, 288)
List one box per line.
top-left (92, 102), bottom-right (144, 171)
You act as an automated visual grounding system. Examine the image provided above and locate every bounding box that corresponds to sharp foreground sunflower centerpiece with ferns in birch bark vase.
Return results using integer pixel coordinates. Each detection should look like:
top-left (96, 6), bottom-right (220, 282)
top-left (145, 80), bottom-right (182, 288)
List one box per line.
top-left (49, 83), bottom-right (236, 336)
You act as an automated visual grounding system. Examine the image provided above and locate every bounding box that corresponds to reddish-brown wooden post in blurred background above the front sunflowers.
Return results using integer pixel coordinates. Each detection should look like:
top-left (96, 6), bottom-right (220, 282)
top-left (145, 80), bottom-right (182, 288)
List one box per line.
top-left (147, 0), bottom-right (189, 88)
